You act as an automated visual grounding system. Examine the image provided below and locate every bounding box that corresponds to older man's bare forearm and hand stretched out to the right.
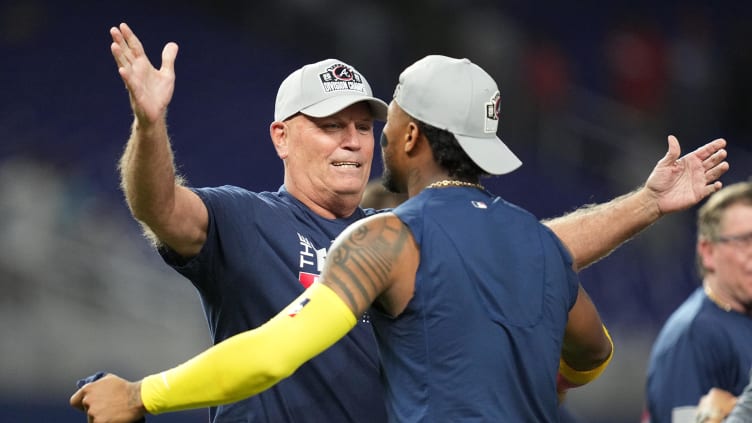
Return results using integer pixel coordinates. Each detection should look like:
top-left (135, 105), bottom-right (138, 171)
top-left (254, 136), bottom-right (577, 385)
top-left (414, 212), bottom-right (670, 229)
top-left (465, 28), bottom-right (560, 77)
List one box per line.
top-left (543, 135), bottom-right (729, 270)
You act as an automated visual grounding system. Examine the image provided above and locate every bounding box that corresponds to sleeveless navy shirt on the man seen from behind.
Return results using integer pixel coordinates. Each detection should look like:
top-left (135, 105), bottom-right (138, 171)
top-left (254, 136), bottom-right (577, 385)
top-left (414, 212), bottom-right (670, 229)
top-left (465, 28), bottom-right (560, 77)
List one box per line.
top-left (371, 187), bottom-right (579, 423)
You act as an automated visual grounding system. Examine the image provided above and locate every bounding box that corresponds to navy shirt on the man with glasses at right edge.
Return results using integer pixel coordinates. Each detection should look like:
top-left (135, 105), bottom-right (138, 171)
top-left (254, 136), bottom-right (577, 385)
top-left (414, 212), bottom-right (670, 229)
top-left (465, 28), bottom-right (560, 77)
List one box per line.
top-left (647, 288), bottom-right (752, 423)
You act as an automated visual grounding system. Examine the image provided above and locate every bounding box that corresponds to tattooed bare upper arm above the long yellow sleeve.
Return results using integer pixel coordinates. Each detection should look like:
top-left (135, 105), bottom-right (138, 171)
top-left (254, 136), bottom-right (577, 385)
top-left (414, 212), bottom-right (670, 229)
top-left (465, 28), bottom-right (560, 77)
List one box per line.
top-left (323, 218), bottom-right (409, 316)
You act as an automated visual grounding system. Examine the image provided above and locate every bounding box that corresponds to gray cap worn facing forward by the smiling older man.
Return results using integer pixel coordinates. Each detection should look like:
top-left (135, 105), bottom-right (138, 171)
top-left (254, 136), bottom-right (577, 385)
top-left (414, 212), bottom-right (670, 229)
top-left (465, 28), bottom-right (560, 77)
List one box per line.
top-left (274, 59), bottom-right (387, 121)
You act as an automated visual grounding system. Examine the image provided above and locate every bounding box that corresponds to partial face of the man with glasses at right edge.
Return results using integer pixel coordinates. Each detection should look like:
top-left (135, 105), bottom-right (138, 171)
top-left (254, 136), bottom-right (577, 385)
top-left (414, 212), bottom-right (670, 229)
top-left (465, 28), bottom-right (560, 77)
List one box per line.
top-left (700, 204), bottom-right (752, 309)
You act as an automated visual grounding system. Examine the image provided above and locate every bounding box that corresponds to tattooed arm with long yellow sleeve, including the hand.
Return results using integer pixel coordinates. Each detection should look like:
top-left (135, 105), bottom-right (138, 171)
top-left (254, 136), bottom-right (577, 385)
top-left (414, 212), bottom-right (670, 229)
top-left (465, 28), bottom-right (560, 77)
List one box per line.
top-left (71, 213), bottom-right (419, 423)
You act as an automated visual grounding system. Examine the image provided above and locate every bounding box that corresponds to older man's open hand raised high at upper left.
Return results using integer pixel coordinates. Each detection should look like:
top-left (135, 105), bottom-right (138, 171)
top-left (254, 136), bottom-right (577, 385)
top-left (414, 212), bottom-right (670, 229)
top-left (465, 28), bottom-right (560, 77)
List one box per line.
top-left (110, 23), bottom-right (178, 125)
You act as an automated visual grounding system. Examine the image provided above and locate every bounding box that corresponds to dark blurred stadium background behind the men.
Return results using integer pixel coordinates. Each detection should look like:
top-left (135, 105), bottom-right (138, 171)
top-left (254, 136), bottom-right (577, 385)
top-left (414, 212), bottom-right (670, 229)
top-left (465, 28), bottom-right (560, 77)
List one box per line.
top-left (0, 0), bottom-right (752, 422)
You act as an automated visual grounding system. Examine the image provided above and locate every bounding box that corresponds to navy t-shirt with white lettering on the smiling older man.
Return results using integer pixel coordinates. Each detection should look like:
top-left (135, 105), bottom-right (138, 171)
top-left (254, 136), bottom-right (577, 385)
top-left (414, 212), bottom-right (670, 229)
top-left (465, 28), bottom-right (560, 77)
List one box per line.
top-left (161, 186), bottom-right (386, 423)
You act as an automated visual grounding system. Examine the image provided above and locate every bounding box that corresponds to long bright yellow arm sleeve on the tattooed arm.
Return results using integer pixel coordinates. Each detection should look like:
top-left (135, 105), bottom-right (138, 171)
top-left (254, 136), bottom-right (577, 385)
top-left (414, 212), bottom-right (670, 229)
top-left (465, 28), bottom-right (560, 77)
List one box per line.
top-left (141, 283), bottom-right (357, 414)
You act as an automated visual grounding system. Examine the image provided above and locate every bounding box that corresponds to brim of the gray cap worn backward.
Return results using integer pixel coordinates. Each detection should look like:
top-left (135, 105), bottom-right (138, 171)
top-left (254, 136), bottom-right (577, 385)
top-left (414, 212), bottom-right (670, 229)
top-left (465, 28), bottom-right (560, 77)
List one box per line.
top-left (455, 134), bottom-right (522, 175)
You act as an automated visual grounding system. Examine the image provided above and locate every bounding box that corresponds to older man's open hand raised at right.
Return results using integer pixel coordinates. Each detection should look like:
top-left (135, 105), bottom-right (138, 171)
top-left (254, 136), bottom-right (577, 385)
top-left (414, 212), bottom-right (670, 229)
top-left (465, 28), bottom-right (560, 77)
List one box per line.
top-left (645, 135), bottom-right (729, 214)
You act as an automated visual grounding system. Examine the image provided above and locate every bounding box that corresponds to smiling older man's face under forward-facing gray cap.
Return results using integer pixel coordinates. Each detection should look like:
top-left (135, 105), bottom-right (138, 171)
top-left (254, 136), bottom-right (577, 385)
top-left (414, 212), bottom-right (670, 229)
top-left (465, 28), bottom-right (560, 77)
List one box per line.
top-left (283, 102), bottom-right (374, 204)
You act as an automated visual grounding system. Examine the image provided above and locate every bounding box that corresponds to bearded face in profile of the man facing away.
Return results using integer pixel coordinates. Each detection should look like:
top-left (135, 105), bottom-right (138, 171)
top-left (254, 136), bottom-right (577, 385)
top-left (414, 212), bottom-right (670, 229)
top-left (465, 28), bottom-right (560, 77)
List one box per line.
top-left (380, 101), bottom-right (412, 193)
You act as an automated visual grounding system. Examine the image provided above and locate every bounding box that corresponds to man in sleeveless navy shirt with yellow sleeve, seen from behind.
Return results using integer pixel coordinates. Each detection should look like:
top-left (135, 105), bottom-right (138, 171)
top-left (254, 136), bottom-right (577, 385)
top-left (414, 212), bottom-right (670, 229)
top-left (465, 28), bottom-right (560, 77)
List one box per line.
top-left (71, 50), bottom-right (723, 422)
